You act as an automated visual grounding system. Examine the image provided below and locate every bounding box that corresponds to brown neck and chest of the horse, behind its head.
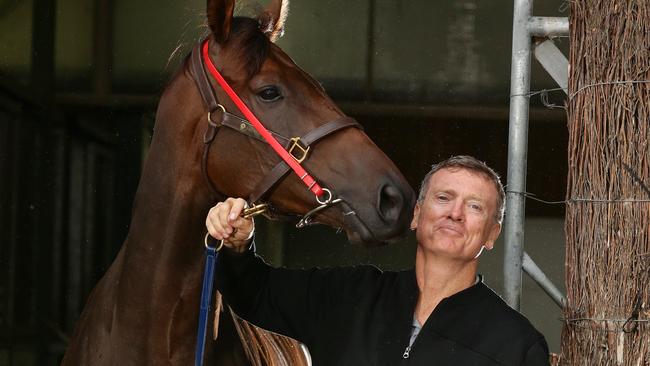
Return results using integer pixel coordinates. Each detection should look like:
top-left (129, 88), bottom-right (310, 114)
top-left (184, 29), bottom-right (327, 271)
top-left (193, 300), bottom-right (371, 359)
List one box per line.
top-left (63, 61), bottom-right (218, 365)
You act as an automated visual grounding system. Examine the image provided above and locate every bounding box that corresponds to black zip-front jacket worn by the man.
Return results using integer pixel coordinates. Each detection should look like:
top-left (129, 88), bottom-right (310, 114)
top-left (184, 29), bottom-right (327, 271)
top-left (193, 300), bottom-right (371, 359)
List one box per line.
top-left (216, 247), bottom-right (549, 366)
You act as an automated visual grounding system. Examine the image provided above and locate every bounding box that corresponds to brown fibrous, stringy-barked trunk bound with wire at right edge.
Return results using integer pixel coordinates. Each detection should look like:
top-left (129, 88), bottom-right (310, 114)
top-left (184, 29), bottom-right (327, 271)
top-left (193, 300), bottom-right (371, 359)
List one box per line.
top-left (560, 0), bottom-right (650, 366)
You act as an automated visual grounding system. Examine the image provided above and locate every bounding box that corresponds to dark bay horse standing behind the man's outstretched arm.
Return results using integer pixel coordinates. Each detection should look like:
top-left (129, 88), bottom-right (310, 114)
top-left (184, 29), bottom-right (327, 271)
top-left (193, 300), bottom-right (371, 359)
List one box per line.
top-left (62, 0), bottom-right (415, 366)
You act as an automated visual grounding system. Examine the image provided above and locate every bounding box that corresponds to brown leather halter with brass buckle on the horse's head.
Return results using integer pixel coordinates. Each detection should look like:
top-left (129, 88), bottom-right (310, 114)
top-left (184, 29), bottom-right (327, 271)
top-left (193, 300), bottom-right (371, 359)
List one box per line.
top-left (191, 42), bottom-right (363, 209)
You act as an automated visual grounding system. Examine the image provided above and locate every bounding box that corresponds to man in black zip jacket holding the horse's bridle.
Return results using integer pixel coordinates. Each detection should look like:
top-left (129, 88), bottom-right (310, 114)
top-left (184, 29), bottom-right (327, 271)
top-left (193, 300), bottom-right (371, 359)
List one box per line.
top-left (206, 156), bottom-right (549, 366)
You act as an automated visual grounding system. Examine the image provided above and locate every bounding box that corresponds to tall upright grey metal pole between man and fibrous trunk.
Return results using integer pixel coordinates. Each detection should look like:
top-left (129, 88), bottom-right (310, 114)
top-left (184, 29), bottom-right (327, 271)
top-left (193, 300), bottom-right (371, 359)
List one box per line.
top-left (503, 0), bottom-right (533, 310)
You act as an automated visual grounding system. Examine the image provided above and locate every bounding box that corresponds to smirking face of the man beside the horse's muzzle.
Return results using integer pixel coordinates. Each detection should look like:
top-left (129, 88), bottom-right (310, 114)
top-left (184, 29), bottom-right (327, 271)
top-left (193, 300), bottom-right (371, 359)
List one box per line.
top-left (411, 168), bottom-right (501, 261)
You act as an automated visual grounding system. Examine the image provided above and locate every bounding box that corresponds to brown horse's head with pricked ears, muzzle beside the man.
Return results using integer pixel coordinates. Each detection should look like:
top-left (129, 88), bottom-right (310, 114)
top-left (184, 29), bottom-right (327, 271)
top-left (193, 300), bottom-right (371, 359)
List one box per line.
top-left (194, 0), bottom-right (415, 244)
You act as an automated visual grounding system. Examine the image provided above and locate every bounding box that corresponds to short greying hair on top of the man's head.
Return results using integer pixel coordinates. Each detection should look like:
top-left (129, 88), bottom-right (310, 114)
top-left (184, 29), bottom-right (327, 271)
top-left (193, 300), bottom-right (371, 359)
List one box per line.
top-left (418, 155), bottom-right (506, 224)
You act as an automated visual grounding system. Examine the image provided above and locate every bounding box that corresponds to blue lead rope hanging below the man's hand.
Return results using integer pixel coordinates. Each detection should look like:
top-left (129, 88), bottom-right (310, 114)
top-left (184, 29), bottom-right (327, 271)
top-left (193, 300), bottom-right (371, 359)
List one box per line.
top-left (194, 240), bottom-right (220, 366)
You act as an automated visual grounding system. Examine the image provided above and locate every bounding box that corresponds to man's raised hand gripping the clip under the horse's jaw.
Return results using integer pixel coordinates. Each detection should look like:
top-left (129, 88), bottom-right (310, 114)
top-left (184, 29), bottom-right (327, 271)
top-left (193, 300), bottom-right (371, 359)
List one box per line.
top-left (205, 198), bottom-right (255, 253)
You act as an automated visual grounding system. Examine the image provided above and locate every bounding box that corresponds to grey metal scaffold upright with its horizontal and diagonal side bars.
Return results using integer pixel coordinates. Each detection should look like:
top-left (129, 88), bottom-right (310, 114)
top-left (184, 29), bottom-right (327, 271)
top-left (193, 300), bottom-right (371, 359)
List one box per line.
top-left (503, 0), bottom-right (569, 310)
